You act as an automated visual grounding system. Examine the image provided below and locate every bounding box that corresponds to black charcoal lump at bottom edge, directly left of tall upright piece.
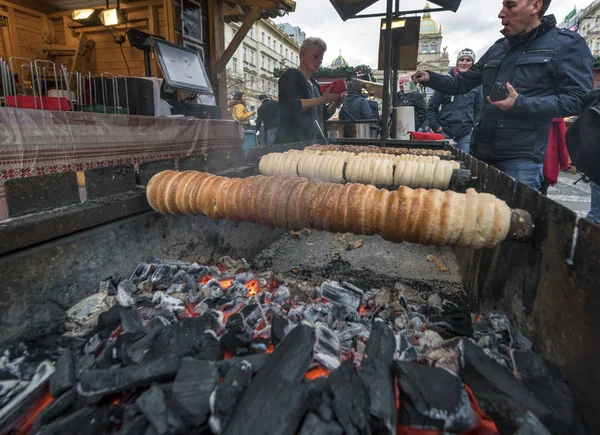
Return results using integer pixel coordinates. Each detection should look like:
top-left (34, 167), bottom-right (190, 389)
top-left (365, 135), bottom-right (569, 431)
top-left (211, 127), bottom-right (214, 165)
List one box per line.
top-left (327, 361), bottom-right (369, 435)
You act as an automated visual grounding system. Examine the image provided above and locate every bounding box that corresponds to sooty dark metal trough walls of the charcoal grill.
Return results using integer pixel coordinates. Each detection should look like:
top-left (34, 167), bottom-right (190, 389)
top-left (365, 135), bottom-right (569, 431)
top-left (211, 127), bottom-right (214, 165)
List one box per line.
top-left (0, 141), bottom-right (600, 432)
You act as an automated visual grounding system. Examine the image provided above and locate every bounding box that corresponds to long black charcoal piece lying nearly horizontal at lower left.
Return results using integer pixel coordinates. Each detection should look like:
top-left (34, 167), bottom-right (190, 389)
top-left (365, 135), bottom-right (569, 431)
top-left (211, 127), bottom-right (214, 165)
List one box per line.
top-left (77, 354), bottom-right (181, 397)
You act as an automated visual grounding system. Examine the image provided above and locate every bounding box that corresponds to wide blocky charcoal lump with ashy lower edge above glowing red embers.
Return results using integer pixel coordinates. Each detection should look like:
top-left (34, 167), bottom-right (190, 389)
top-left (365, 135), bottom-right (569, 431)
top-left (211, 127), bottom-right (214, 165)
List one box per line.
top-left (393, 361), bottom-right (478, 432)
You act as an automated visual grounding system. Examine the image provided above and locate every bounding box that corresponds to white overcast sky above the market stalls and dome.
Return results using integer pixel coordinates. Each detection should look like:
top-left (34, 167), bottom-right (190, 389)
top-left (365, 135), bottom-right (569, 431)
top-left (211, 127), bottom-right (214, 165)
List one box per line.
top-left (275, 0), bottom-right (592, 69)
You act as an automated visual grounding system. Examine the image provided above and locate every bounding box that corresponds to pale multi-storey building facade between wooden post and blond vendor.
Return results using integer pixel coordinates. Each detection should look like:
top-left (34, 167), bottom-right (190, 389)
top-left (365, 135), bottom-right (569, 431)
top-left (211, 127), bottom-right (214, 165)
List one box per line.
top-left (225, 19), bottom-right (300, 111)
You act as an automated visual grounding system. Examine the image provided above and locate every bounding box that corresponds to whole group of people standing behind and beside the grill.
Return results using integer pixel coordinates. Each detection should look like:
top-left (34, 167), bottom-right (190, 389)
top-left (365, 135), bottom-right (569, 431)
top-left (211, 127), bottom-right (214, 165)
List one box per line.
top-left (232, 0), bottom-right (600, 222)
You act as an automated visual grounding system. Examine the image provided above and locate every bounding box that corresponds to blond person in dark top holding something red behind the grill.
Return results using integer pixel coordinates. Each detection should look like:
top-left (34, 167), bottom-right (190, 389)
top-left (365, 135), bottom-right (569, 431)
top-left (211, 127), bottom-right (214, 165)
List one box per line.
top-left (276, 38), bottom-right (343, 143)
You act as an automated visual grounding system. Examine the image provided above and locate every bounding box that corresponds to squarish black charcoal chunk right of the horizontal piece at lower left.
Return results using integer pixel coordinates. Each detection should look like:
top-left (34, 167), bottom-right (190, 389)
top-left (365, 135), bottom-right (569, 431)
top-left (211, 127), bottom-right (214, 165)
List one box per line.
top-left (172, 358), bottom-right (219, 426)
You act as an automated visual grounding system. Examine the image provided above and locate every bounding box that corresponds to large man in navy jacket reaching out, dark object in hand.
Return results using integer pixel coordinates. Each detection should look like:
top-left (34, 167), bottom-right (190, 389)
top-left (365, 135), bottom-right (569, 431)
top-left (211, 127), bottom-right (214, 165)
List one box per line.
top-left (413, 0), bottom-right (593, 189)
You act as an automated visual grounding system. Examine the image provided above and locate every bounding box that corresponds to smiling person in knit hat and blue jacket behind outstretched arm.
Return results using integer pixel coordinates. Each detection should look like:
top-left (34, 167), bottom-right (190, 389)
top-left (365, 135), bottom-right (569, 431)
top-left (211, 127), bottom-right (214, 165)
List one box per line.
top-left (427, 48), bottom-right (483, 153)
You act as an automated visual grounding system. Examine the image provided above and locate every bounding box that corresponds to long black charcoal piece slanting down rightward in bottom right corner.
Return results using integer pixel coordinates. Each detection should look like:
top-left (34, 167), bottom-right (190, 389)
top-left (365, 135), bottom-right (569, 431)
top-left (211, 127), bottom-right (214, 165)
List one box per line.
top-left (458, 339), bottom-right (554, 433)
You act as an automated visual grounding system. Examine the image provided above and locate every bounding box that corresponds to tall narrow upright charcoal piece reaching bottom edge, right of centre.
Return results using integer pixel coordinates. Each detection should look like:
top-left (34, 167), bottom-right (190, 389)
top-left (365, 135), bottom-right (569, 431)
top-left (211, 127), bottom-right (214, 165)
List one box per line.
top-left (359, 321), bottom-right (397, 435)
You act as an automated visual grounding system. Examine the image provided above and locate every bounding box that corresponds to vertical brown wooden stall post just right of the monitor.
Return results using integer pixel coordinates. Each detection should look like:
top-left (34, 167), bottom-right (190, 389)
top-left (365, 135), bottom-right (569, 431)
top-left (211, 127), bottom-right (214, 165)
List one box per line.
top-left (208, 0), bottom-right (229, 119)
